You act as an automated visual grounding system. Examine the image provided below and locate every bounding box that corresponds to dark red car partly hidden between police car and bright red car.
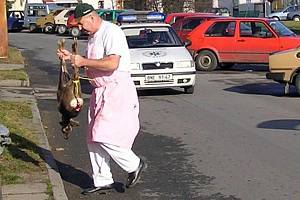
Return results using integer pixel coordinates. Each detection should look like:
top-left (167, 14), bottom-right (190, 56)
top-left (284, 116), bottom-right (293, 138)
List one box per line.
top-left (172, 14), bottom-right (220, 42)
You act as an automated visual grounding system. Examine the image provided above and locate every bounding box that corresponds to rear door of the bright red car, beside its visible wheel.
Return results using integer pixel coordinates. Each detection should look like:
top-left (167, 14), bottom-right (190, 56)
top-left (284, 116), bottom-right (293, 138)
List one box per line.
top-left (201, 20), bottom-right (236, 62)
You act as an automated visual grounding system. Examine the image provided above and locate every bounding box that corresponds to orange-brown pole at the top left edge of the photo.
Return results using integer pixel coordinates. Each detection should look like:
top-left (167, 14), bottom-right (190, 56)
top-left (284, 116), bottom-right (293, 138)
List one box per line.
top-left (0, 0), bottom-right (8, 58)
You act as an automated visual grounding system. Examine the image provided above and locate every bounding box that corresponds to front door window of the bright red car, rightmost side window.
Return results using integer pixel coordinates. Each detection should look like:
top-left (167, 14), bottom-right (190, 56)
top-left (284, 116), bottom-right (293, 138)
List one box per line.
top-left (240, 21), bottom-right (273, 38)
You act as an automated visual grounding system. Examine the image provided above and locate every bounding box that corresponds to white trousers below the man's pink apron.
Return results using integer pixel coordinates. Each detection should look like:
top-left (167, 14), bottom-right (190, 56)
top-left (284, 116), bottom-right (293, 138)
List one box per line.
top-left (88, 143), bottom-right (140, 187)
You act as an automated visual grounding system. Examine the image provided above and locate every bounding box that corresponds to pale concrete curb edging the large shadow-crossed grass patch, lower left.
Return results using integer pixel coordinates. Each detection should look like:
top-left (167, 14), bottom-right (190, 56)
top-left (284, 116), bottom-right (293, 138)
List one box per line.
top-left (31, 101), bottom-right (68, 200)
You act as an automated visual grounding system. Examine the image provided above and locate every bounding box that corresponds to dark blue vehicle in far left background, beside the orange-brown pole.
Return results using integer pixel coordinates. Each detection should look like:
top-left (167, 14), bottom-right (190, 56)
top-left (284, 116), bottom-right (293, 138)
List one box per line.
top-left (7, 10), bottom-right (24, 31)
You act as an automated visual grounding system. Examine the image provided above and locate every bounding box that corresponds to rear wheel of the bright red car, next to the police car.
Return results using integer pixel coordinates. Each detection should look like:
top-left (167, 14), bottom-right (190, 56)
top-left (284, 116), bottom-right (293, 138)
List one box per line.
top-left (195, 50), bottom-right (218, 71)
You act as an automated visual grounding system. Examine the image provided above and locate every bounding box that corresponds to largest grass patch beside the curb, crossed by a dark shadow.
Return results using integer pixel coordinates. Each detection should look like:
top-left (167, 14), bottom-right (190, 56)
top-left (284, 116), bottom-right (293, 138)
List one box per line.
top-left (0, 101), bottom-right (46, 184)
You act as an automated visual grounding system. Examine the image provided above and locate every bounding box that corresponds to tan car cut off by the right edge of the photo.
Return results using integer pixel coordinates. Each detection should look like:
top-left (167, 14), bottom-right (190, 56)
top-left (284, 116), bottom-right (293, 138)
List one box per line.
top-left (266, 47), bottom-right (300, 95)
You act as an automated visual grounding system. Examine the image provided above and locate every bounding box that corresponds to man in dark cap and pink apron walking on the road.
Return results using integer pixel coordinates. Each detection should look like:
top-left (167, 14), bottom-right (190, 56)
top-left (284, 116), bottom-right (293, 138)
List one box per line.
top-left (57, 3), bottom-right (144, 194)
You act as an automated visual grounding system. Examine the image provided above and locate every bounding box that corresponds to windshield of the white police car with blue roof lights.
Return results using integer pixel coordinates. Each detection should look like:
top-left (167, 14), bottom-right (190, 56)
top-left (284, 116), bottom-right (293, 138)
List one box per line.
top-left (123, 27), bottom-right (183, 48)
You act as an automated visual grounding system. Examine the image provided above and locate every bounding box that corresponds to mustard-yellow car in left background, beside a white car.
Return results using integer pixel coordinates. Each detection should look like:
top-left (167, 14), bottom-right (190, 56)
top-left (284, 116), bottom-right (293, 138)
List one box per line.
top-left (36, 9), bottom-right (63, 33)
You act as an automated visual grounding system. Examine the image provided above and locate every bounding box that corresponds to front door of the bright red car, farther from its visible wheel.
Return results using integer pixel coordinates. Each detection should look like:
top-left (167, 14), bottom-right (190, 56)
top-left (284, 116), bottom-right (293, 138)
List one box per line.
top-left (235, 20), bottom-right (280, 63)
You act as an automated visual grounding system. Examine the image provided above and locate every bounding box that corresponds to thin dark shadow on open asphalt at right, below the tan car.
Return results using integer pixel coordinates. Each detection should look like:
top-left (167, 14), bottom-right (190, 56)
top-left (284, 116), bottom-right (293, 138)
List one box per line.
top-left (257, 119), bottom-right (300, 130)
